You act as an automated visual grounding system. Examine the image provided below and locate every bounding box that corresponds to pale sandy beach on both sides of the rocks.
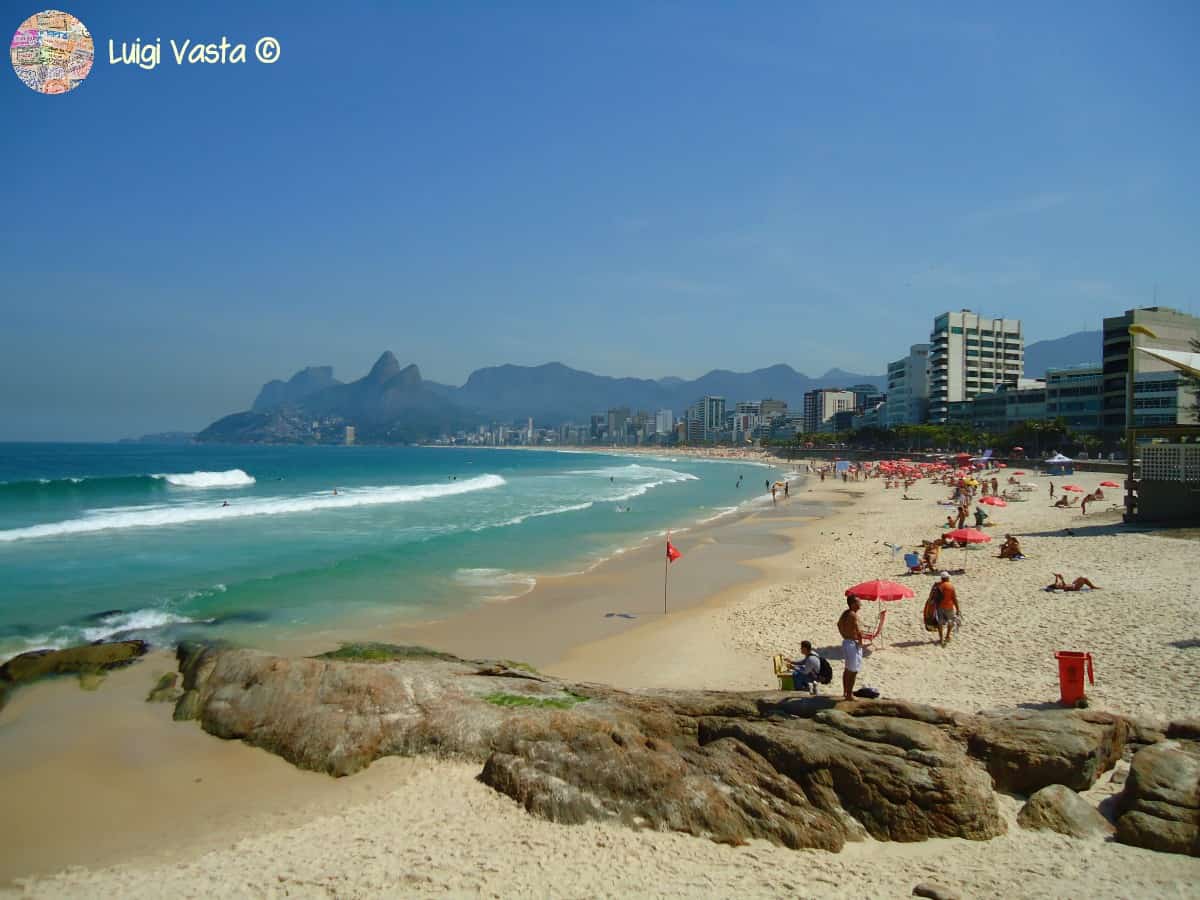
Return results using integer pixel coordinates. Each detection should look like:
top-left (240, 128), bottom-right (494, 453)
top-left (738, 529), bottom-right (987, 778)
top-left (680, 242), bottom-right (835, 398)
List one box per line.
top-left (0, 460), bottom-right (1200, 898)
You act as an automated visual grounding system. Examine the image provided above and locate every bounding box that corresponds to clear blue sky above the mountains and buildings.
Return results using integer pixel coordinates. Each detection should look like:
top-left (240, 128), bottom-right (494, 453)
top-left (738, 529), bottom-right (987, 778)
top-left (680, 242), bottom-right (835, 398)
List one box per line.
top-left (0, 0), bottom-right (1200, 439)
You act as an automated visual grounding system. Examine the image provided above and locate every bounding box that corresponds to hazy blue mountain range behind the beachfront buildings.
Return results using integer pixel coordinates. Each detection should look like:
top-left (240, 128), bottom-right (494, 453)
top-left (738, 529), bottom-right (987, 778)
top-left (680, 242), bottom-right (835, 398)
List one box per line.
top-left (198, 331), bottom-right (1100, 443)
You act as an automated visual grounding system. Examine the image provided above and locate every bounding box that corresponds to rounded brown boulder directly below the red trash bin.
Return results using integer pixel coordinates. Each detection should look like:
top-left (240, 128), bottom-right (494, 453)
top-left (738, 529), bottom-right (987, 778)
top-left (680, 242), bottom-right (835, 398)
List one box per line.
top-left (968, 709), bottom-right (1129, 794)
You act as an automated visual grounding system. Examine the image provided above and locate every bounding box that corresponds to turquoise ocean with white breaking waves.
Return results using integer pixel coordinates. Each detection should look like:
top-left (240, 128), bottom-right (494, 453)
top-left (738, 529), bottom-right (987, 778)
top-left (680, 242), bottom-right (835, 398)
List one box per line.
top-left (0, 444), bottom-right (780, 660)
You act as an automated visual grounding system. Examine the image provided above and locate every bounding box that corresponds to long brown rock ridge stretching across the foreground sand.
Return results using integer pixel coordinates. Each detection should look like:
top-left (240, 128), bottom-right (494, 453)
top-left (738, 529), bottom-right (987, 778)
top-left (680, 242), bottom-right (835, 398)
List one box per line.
top-left (175, 646), bottom-right (1194, 851)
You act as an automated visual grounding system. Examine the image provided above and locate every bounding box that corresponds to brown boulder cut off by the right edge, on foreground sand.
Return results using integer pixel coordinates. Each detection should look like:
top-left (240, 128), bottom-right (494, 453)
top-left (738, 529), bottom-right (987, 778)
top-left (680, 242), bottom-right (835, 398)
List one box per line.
top-left (1117, 740), bottom-right (1200, 857)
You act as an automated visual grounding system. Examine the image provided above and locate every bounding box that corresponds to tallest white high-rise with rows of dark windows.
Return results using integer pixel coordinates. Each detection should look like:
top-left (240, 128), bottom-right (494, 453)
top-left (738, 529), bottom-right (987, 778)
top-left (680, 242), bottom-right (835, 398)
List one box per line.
top-left (929, 310), bottom-right (1025, 425)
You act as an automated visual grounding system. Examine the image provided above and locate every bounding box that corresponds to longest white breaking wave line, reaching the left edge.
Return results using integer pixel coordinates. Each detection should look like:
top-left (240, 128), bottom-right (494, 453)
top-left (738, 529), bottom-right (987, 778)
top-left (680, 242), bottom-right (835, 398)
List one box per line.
top-left (0, 475), bottom-right (505, 542)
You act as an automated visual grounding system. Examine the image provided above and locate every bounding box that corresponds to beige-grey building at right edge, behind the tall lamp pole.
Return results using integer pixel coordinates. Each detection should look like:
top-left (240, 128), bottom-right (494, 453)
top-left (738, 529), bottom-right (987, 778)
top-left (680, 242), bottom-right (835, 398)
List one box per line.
top-left (1100, 306), bottom-right (1200, 439)
